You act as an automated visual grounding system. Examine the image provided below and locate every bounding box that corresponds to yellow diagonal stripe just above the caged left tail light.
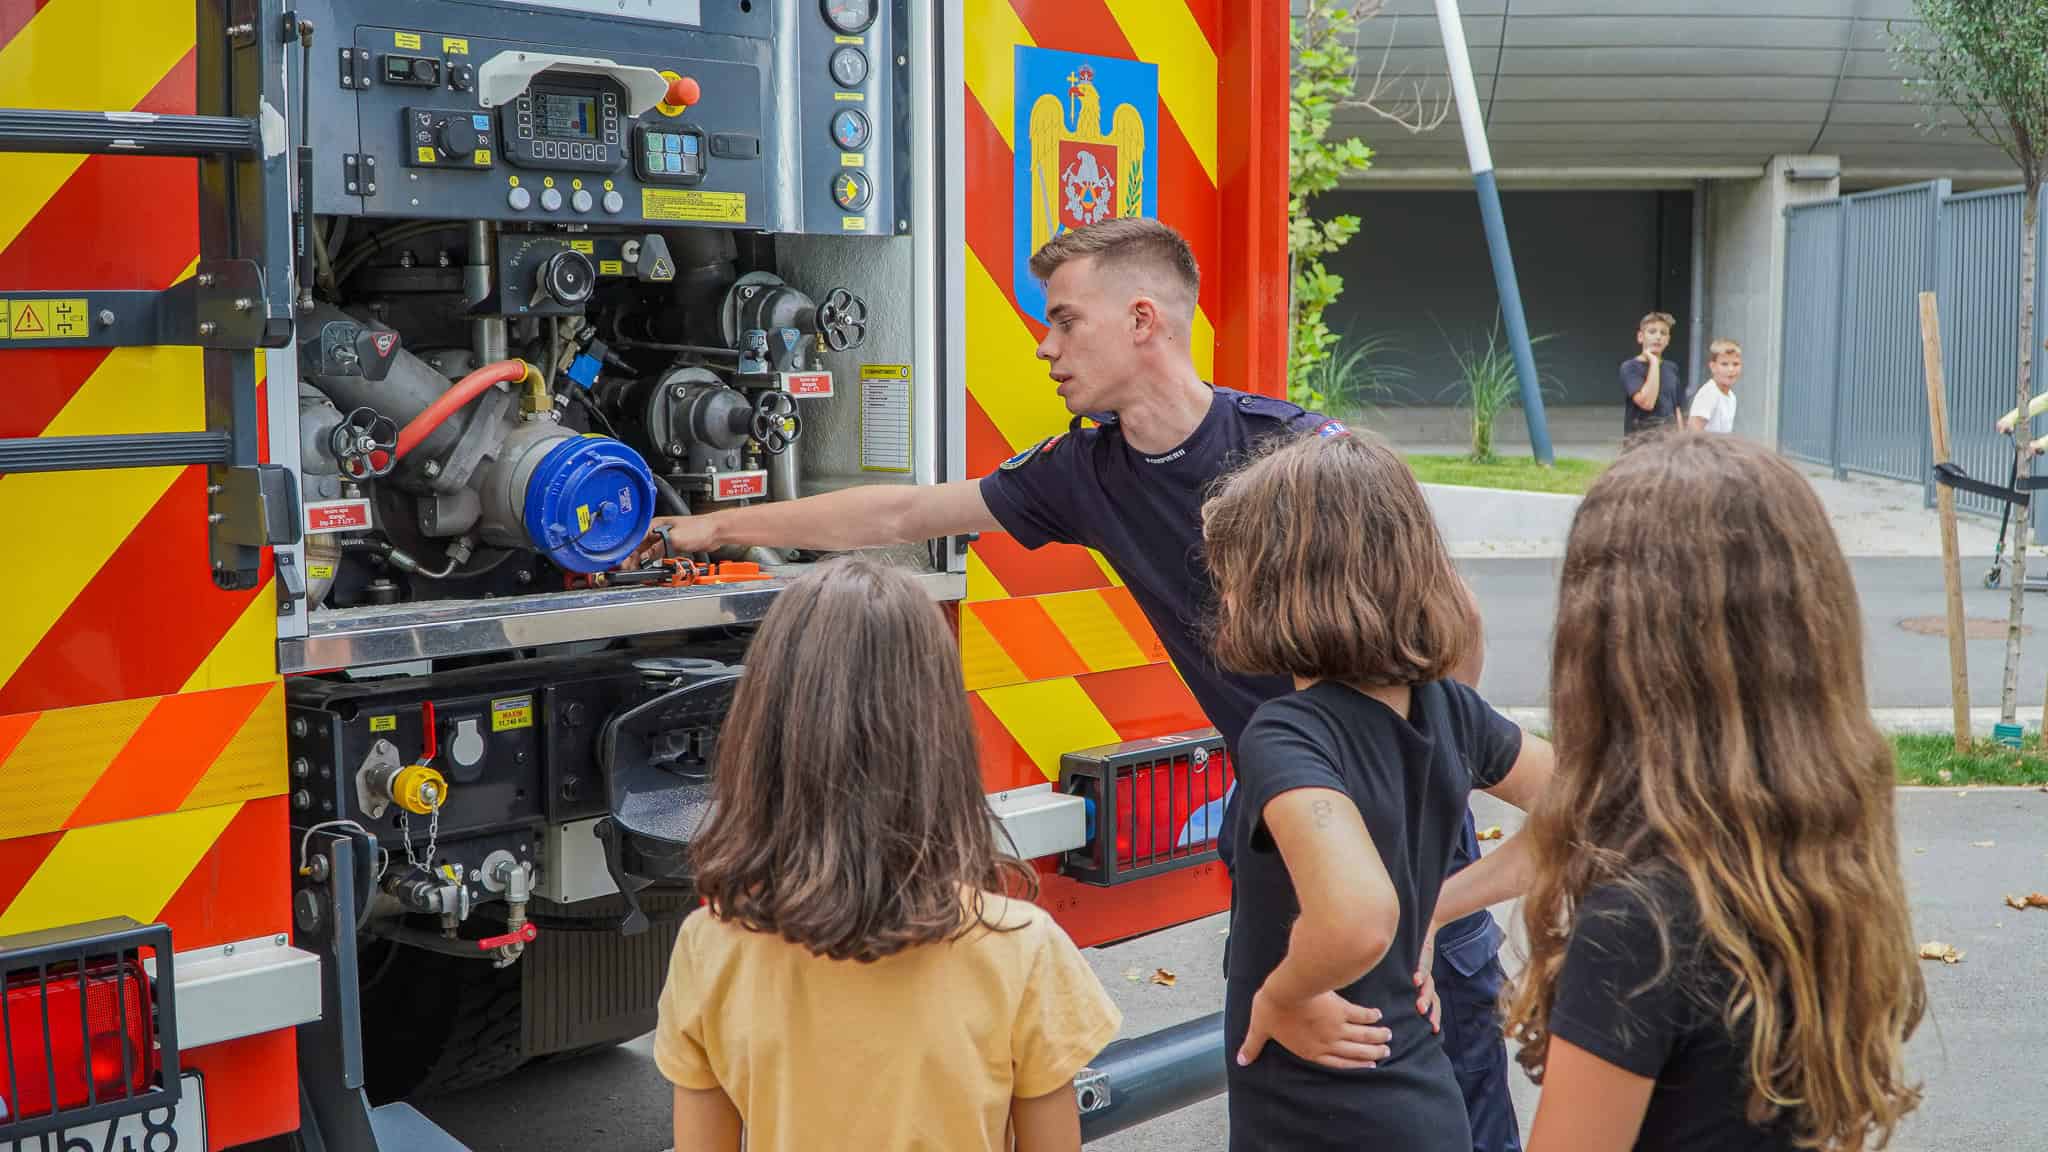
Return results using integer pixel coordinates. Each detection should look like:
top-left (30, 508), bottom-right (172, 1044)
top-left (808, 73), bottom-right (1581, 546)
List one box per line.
top-left (0, 804), bottom-right (242, 937)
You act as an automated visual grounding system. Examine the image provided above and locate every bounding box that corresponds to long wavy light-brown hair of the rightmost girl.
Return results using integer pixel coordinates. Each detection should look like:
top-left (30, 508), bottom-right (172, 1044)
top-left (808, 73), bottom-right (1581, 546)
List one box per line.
top-left (1507, 433), bottom-right (1925, 1150)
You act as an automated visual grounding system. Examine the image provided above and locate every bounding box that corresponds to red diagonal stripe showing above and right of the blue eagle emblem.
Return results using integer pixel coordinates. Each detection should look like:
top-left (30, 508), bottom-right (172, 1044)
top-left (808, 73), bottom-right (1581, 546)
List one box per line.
top-left (1003, 0), bottom-right (1223, 330)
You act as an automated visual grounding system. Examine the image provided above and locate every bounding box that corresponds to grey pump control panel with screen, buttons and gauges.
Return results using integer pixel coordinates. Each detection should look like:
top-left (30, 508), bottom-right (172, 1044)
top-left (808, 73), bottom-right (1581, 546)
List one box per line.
top-left (307, 0), bottom-right (909, 236)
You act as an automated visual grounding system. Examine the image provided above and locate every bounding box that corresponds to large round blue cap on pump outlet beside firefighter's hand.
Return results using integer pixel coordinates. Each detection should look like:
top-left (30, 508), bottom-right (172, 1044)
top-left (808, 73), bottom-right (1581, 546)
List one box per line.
top-left (526, 437), bottom-right (653, 572)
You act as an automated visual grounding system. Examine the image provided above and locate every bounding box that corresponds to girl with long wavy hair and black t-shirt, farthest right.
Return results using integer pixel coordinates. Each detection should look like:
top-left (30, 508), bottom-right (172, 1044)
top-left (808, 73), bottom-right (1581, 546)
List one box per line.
top-left (1438, 435), bottom-right (1925, 1152)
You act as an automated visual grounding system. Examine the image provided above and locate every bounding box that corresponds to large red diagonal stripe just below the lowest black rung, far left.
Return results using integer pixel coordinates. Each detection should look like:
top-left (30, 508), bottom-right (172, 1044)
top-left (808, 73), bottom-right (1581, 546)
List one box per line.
top-left (0, 467), bottom-right (268, 713)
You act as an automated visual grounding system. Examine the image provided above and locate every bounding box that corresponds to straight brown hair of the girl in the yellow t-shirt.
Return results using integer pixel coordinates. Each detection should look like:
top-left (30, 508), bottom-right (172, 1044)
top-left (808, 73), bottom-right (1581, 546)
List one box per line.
top-left (692, 558), bottom-right (1036, 961)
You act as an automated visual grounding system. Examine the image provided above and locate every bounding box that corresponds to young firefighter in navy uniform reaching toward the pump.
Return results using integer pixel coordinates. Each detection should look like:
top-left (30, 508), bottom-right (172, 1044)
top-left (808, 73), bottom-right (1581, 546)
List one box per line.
top-left (638, 217), bottom-right (1518, 1152)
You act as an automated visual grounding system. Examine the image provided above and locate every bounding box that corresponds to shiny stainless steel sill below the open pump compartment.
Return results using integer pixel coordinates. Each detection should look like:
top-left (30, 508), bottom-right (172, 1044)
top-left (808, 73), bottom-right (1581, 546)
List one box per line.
top-left (279, 572), bottom-right (967, 674)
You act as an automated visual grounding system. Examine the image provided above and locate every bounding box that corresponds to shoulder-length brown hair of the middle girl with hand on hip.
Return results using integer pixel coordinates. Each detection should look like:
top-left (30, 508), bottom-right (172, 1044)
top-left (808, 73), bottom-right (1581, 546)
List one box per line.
top-left (1202, 433), bottom-right (1479, 687)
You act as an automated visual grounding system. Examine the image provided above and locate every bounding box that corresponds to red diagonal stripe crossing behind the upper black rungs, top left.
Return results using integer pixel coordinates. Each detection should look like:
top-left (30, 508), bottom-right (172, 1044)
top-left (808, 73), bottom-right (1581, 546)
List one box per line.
top-left (0, 47), bottom-right (199, 437)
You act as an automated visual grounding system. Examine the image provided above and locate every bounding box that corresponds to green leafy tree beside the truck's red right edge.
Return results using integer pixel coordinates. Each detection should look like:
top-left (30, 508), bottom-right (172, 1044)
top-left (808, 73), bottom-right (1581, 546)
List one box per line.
top-left (1286, 0), bottom-right (1372, 408)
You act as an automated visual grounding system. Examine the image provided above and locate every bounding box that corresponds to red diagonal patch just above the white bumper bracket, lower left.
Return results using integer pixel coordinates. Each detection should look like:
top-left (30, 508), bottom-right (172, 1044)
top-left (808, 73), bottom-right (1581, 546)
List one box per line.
top-left (158, 795), bottom-right (299, 949)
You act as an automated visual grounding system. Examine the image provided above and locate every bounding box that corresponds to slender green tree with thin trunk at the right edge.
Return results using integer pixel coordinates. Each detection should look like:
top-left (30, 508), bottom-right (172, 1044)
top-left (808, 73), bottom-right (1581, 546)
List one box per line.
top-left (1892, 0), bottom-right (2048, 724)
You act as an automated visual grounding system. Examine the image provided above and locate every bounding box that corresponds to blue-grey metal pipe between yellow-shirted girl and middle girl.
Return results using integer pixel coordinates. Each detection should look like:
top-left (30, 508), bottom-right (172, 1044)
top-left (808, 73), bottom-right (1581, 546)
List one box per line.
top-left (1073, 1013), bottom-right (1225, 1144)
